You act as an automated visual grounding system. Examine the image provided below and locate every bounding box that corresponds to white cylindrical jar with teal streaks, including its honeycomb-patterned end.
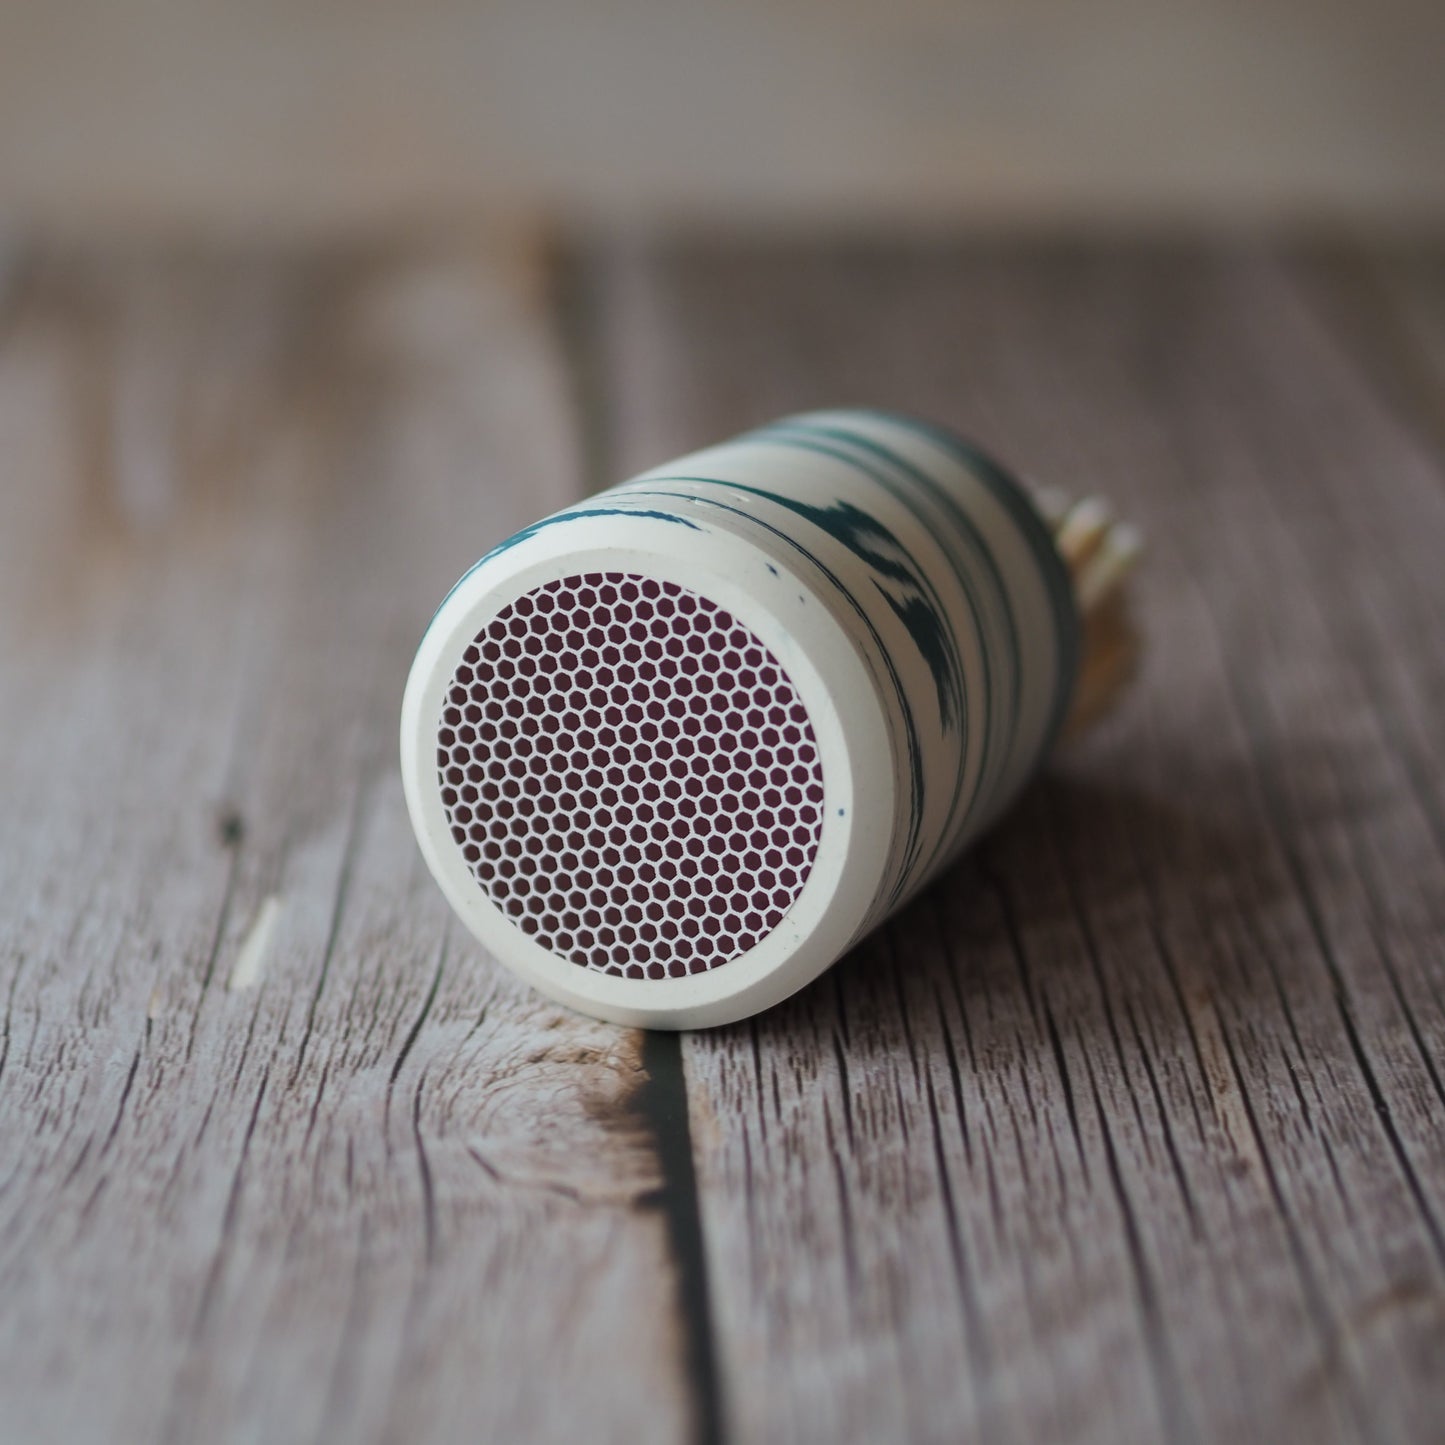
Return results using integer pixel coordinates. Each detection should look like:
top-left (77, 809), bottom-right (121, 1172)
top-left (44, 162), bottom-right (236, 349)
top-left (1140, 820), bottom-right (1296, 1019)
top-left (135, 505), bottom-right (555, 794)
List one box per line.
top-left (402, 410), bottom-right (1081, 1027)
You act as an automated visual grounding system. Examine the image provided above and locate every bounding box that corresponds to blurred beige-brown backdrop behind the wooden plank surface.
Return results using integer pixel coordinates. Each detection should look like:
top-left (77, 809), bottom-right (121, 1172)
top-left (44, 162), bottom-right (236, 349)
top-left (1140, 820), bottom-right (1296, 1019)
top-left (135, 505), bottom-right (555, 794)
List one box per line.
top-left (0, 0), bottom-right (1445, 233)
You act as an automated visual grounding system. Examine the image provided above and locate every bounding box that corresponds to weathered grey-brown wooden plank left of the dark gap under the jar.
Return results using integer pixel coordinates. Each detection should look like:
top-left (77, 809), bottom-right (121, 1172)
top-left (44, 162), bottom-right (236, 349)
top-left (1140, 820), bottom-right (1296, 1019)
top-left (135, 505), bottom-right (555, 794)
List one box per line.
top-left (0, 251), bottom-right (688, 1442)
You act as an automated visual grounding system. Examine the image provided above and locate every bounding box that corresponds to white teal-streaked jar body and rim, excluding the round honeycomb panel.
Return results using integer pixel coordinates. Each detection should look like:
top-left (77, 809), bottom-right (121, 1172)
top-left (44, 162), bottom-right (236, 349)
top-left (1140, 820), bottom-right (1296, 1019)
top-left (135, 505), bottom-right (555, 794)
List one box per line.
top-left (402, 410), bottom-right (1079, 1029)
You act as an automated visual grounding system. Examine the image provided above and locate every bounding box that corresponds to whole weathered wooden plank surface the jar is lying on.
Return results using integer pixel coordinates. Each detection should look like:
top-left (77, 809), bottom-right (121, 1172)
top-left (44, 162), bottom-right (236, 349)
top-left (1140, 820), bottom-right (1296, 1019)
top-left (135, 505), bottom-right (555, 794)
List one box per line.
top-left (0, 231), bottom-right (1445, 1442)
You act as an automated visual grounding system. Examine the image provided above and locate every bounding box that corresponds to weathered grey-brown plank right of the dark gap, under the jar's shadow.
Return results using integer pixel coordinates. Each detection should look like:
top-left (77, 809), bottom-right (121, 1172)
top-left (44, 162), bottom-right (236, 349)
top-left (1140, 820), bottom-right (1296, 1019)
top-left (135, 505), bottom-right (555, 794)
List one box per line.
top-left (597, 247), bottom-right (1445, 1442)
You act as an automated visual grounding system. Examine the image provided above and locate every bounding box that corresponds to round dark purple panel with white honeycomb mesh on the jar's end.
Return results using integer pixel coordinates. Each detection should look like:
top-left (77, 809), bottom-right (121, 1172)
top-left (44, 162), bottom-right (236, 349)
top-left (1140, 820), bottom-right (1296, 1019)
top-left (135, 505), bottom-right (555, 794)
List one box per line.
top-left (436, 572), bottom-right (824, 978)
